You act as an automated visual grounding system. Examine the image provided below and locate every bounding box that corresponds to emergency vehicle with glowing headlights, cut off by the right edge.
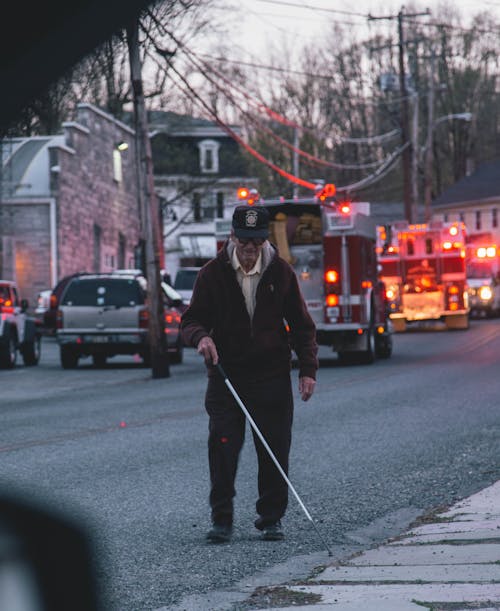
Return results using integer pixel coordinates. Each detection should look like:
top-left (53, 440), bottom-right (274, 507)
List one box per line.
top-left (465, 235), bottom-right (500, 318)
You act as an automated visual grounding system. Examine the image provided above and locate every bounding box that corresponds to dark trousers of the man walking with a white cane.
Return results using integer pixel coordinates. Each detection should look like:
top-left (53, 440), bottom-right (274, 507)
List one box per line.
top-left (205, 374), bottom-right (293, 529)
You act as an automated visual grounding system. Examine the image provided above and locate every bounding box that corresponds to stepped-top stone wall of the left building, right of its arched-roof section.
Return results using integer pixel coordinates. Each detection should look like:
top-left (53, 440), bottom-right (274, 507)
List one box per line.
top-left (55, 106), bottom-right (139, 277)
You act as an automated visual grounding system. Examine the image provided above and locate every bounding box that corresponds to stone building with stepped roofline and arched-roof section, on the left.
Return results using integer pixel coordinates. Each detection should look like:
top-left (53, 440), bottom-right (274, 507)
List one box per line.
top-left (0, 104), bottom-right (140, 303)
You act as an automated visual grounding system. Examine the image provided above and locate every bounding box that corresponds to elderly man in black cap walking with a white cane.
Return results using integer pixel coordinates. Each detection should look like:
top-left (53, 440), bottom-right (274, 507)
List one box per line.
top-left (181, 205), bottom-right (318, 543)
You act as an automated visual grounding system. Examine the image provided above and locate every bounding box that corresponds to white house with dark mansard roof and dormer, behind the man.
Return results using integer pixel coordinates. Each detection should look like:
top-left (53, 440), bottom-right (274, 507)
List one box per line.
top-left (148, 111), bottom-right (258, 278)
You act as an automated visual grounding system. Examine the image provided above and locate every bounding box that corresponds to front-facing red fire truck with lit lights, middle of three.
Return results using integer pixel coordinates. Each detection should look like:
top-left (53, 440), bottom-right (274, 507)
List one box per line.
top-left (377, 221), bottom-right (469, 332)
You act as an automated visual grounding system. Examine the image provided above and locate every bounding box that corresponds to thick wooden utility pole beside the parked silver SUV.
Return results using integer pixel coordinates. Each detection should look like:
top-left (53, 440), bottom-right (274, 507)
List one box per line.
top-left (127, 19), bottom-right (170, 378)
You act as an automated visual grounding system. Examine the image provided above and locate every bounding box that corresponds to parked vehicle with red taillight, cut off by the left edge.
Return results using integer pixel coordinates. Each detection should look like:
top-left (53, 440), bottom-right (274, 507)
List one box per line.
top-left (0, 280), bottom-right (41, 369)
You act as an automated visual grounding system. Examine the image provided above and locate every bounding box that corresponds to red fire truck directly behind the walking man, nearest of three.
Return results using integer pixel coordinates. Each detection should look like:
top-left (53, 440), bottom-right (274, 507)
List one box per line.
top-left (216, 190), bottom-right (393, 364)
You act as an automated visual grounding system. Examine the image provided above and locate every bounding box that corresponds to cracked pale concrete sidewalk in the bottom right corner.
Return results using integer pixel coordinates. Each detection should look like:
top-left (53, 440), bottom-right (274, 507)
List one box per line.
top-left (258, 481), bottom-right (500, 611)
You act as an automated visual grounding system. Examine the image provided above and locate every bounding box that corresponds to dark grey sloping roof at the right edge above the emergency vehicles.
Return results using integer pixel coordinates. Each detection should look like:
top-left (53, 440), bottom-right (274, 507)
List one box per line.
top-left (432, 159), bottom-right (500, 208)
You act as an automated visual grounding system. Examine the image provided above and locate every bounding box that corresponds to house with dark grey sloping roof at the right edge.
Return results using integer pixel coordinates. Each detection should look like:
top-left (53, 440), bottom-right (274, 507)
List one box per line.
top-left (431, 159), bottom-right (500, 244)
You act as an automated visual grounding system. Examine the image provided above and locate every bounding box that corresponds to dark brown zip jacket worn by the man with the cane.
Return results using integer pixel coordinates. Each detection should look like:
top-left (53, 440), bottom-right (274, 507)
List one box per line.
top-left (181, 242), bottom-right (318, 380)
